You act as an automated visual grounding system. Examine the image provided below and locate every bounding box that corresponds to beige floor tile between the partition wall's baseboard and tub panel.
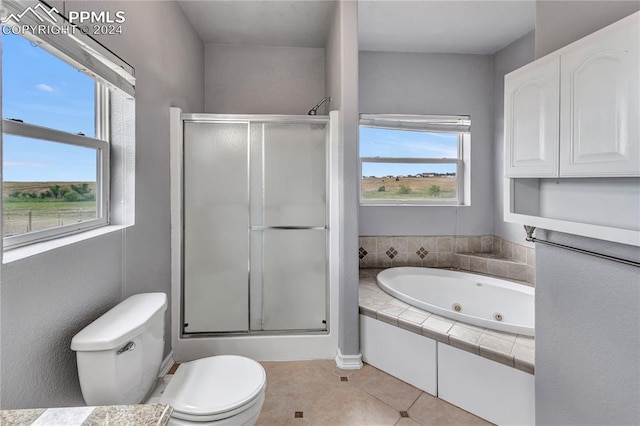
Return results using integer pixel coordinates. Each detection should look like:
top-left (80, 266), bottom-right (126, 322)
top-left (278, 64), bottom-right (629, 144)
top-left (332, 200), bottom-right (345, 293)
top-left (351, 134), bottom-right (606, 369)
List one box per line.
top-left (349, 364), bottom-right (422, 411)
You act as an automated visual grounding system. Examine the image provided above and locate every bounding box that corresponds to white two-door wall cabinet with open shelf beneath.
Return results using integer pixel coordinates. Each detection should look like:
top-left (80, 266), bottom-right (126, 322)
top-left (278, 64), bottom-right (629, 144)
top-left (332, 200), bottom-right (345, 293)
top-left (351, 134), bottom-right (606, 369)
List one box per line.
top-left (504, 12), bottom-right (640, 246)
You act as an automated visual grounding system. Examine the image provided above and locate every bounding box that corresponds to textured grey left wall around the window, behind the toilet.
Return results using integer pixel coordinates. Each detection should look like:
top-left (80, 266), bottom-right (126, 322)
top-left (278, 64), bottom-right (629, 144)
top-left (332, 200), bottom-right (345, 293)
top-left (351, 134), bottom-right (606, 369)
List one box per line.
top-left (0, 1), bottom-right (204, 409)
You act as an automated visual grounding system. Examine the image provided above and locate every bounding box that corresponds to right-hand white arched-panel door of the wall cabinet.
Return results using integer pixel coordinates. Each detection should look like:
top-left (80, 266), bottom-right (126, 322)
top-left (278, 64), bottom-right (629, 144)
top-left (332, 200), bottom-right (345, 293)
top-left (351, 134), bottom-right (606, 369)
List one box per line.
top-left (560, 13), bottom-right (640, 176)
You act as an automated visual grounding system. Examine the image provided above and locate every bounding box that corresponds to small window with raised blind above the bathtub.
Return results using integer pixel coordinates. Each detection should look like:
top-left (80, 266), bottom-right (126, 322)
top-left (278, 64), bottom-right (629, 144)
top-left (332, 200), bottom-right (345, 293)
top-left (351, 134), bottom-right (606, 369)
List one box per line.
top-left (359, 114), bottom-right (471, 205)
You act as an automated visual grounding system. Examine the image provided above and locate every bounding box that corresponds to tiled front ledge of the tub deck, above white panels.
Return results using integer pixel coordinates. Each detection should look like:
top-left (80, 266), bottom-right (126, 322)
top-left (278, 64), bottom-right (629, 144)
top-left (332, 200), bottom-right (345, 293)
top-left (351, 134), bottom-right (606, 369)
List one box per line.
top-left (359, 269), bottom-right (535, 374)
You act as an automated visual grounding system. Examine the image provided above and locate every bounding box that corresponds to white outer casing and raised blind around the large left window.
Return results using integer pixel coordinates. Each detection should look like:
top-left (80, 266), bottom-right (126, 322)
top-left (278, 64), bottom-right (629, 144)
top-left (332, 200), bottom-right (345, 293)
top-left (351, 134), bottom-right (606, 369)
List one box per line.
top-left (0, 0), bottom-right (136, 255)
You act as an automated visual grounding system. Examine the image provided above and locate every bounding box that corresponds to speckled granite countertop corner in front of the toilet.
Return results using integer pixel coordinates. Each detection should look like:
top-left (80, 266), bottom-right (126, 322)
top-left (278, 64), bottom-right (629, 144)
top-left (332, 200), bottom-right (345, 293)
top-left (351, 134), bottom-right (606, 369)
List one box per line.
top-left (0, 404), bottom-right (173, 426)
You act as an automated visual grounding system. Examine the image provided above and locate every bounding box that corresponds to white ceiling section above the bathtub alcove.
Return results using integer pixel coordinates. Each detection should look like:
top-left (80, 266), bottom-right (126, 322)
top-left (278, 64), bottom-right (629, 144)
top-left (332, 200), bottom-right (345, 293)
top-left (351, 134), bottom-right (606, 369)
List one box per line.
top-left (358, 0), bottom-right (535, 54)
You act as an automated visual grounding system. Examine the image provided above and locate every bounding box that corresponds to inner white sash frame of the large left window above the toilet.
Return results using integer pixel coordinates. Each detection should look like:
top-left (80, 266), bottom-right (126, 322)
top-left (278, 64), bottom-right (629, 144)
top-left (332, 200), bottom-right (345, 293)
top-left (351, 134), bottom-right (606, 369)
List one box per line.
top-left (2, 82), bottom-right (111, 251)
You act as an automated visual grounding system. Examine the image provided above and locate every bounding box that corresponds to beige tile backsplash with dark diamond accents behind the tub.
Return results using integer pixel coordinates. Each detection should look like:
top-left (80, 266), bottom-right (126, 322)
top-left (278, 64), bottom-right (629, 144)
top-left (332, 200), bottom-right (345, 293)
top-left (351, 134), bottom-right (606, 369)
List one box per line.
top-left (358, 235), bottom-right (535, 284)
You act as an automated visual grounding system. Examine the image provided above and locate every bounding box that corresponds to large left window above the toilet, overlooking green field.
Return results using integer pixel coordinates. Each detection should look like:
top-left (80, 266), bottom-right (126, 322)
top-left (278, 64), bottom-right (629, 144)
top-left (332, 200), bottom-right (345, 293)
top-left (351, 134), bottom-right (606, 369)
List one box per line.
top-left (2, 34), bottom-right (109, 248)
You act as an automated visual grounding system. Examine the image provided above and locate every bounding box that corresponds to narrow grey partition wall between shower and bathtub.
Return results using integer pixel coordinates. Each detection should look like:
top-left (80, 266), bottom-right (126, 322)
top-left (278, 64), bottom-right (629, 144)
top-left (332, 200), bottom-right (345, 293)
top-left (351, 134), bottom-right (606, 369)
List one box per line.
top-left (326, 1), bottom-right (360, 356)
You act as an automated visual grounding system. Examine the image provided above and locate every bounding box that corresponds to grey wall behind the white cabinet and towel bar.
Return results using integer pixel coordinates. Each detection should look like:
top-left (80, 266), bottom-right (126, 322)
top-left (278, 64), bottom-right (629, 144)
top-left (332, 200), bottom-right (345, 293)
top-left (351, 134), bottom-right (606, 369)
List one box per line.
top-left (536, 1), bottom-right (640, 425)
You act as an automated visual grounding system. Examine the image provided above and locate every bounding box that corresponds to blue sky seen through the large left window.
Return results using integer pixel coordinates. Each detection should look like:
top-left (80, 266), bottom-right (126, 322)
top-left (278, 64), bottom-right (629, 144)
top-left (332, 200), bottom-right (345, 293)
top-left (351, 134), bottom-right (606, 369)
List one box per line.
top-left (2, 30), bottom-right (96, 182)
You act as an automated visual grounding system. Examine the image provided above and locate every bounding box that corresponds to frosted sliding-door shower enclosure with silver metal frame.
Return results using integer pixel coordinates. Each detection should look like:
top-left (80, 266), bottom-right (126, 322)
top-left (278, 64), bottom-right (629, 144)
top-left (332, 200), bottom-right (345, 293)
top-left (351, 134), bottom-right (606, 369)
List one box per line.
top-left (172, 109), bottom-right (340, 360)
